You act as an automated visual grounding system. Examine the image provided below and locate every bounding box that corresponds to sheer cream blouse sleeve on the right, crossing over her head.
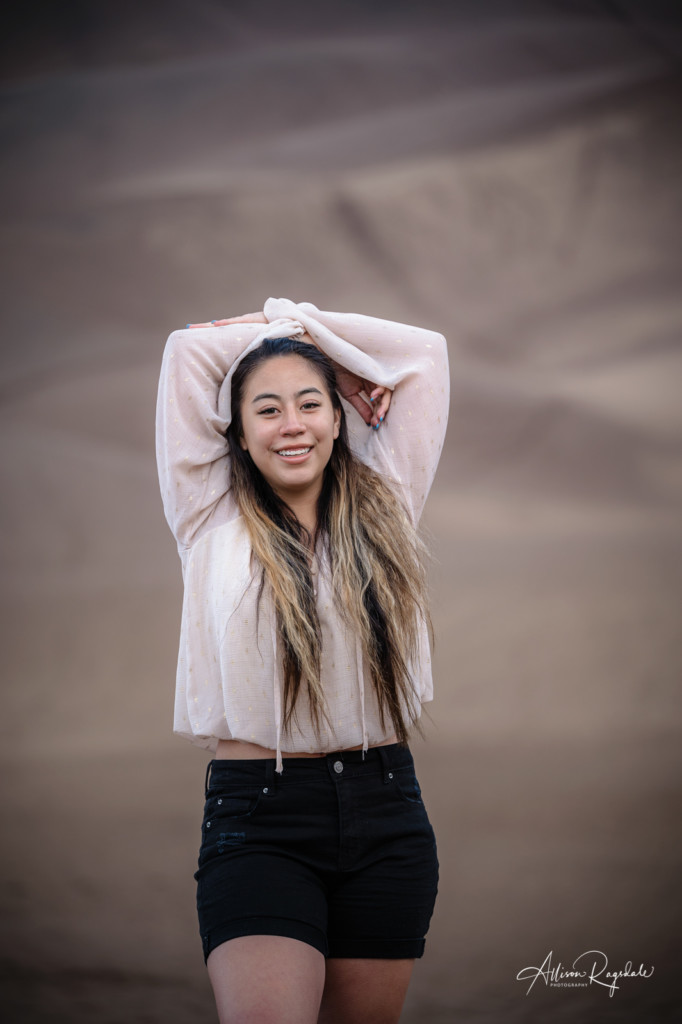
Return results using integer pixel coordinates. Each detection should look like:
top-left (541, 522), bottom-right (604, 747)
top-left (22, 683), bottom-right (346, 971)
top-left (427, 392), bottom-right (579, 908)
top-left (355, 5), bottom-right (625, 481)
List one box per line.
top-left (264, 299), bottom-right (450, 523)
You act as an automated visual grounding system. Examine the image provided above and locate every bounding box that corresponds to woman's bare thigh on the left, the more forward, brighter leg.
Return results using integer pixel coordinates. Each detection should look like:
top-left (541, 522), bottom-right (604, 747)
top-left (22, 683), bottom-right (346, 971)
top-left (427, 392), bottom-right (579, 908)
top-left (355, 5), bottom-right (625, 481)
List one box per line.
top-left (207, 935), bottom-right (325, 1024)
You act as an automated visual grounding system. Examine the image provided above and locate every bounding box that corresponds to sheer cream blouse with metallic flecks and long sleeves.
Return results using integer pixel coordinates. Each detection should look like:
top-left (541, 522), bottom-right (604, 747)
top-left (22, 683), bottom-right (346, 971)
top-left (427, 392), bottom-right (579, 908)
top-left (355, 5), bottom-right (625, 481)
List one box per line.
top-left (157, 298), bottom-right (450, 772)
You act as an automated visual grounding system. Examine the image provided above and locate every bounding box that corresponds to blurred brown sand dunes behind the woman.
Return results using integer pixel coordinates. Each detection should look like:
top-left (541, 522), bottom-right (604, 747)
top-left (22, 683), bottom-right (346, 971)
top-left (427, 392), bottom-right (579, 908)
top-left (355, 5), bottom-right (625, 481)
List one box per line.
top-left (0, 0), bottom-right (682, 1024)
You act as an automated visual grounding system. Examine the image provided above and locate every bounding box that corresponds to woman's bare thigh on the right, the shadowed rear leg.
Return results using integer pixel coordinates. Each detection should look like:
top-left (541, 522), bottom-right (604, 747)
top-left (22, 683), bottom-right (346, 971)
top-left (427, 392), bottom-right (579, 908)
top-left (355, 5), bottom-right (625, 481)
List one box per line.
top-left (318, 957), bottom-right (415, 1024)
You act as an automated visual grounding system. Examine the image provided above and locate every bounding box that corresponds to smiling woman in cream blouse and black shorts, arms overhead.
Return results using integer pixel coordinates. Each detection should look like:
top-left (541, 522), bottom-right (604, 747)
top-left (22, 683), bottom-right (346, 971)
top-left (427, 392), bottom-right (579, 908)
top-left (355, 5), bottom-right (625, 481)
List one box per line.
top-left (158, 299), bottom-right (449, 1024)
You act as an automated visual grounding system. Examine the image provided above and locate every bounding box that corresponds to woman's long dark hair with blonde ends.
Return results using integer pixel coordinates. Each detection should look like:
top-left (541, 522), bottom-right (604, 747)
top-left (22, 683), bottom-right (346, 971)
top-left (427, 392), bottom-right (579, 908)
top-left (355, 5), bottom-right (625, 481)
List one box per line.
top-left (226, 338), bottom-right (433, 743)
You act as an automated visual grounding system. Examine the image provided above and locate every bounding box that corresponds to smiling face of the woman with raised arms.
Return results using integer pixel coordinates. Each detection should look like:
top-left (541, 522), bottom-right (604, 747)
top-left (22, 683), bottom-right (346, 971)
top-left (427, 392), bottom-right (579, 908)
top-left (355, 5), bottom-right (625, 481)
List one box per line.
top-left (240, 355), bottom-right (341, 511)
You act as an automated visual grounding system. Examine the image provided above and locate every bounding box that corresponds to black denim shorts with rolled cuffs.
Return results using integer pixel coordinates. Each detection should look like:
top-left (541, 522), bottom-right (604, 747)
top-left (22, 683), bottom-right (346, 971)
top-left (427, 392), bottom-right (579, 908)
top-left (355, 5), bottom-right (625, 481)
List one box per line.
top-left (195, 743), bottom-right (438, 961)
